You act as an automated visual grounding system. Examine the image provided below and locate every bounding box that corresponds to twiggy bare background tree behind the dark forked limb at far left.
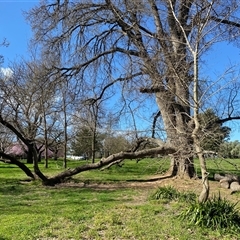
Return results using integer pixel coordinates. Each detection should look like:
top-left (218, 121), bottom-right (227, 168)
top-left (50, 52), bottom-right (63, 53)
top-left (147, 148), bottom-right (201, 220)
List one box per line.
top-left (0, 63), bottom-right (42, 163)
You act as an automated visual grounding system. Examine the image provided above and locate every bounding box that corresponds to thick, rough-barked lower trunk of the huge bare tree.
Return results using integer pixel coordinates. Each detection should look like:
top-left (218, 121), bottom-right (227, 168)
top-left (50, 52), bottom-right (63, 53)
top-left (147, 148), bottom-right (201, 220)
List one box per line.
top-left (156, 93), bottom-right (196, 178)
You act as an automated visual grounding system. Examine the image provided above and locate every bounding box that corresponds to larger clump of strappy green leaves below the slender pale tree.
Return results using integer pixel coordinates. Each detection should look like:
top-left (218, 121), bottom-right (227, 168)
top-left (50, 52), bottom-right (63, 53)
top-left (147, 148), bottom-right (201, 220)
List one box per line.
top-left (180, 195), bottom-right (240, 232)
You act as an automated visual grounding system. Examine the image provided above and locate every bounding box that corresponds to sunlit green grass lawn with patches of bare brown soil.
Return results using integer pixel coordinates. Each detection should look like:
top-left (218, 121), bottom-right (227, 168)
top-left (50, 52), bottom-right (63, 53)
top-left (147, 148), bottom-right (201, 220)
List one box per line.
top-left (0, 159), bottom-right (240, 240)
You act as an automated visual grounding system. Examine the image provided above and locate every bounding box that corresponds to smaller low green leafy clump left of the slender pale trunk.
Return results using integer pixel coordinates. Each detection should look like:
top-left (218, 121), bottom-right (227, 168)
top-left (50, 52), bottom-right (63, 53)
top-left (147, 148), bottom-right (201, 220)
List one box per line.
top-left (151, 186), bottom-right (196, 201)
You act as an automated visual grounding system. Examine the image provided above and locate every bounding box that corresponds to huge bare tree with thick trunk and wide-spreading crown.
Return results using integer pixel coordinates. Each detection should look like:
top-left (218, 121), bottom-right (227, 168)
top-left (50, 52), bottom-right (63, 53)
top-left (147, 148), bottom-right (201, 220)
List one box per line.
top-left (25, 0), bottom-right (240, 182)
